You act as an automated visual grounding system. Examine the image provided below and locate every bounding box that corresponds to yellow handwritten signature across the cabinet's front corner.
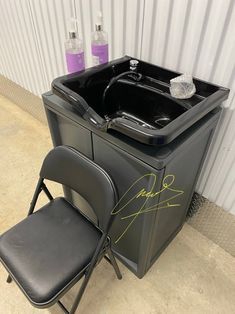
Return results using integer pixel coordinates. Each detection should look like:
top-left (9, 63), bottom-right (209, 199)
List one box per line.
top-left (111, 173), bottom-right (184, 243)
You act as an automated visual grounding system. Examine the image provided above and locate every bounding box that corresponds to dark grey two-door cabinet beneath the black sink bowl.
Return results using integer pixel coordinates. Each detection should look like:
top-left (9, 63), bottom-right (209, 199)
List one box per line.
top-left (43, 93), bottom-right (221, 278)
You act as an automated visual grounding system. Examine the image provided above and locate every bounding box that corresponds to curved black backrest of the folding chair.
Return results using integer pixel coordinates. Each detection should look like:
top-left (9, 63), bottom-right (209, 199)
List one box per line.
top-left (40, 146), bottom-right (117, 231)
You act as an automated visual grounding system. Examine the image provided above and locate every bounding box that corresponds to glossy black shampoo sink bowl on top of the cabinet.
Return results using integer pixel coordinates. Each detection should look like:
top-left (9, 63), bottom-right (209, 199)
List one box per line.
top-left (52, 56), bottom-right (229, 145)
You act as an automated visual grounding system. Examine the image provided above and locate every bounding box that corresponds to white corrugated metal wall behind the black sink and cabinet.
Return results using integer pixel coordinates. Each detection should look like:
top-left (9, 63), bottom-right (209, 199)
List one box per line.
top-left (0, 0), bottom-right (235, 214)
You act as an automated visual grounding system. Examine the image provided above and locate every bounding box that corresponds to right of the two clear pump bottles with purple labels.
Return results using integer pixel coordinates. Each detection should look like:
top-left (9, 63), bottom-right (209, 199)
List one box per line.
top-left (91, 12), bottom-right (109, 65)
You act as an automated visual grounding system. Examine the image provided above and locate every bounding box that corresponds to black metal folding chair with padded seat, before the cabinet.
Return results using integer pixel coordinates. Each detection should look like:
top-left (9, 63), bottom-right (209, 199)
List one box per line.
top-left (0, 146), bottom-right (122, 314)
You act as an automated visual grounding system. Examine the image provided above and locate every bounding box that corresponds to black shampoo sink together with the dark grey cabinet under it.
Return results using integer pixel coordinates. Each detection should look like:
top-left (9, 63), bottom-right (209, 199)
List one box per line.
top-left (43, 57), bottom-right (229, 278)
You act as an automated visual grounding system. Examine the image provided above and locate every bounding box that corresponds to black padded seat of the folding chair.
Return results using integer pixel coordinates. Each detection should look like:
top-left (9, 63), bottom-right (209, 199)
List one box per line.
top-left (0, 198), bottom-right (102, 306)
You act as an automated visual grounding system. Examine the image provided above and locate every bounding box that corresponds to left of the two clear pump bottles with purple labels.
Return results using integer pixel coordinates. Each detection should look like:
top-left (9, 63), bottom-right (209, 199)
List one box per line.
top-left (65, 18), bottom-right (85, 73)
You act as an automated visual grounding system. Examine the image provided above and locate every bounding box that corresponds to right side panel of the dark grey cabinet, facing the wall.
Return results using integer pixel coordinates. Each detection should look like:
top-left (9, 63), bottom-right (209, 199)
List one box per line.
top-left (149, 129), bottom-right (211, 267)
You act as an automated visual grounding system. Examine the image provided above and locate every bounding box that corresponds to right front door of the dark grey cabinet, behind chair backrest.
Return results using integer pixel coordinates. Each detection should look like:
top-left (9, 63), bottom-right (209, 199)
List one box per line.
top-left (93, 135), bottom-right (162, 277)
